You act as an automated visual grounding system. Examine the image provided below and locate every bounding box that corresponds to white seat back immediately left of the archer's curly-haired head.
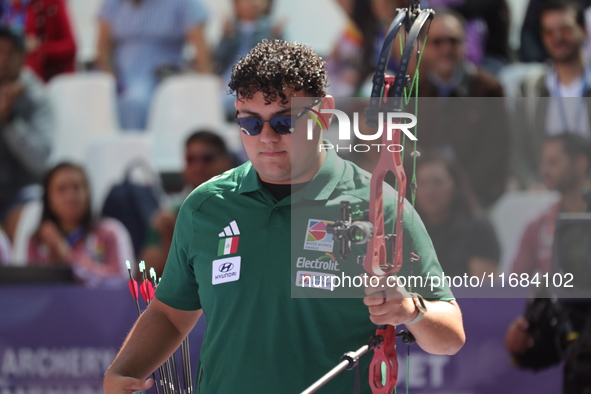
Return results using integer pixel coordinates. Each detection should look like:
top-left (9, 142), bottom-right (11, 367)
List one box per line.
top-left (147, 74), bottom-right (224, 172)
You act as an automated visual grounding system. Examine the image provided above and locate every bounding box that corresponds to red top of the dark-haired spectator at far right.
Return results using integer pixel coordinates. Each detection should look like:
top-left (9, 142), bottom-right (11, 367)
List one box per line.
top-left (512, 203), bottom-right (560, 274)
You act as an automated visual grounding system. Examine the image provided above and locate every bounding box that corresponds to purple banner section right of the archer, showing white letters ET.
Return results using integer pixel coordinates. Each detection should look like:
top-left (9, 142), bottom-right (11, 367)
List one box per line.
top-left (398, 299), bottom-right (562, 394)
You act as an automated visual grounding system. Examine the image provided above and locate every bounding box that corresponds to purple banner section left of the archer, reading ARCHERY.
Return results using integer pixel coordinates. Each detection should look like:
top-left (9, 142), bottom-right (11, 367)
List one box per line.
top-left (0, 286), bottom-right (205, 394)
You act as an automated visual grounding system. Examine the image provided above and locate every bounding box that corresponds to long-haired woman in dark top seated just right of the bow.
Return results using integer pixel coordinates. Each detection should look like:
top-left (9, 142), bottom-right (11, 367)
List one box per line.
top-left (416, 155), bottom-right (500, 277)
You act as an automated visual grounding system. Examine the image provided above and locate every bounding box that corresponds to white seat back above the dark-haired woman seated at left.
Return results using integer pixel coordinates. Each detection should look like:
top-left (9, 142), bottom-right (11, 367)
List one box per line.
top-left (48, 73), bottom-right (119, 164)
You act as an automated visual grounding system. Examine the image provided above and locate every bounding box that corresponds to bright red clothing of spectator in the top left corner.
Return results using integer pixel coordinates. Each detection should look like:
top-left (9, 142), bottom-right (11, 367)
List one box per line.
top-left (4, 0), bottom-right (76, 81)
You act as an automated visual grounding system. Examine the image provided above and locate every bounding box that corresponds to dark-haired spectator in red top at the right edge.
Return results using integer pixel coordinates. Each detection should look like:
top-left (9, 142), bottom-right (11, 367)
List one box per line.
top-left (512, 133), bottom-right (591, 273)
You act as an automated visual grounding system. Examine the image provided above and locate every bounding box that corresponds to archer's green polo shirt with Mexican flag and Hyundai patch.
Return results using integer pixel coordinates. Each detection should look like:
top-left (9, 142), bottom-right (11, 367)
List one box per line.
top-left (156, 152), bottom-right (453, 394)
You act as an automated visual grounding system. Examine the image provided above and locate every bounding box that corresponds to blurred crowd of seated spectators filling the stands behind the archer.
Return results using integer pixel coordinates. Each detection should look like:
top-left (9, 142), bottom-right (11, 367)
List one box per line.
top-left (0, 0), bottom-right (591, 285)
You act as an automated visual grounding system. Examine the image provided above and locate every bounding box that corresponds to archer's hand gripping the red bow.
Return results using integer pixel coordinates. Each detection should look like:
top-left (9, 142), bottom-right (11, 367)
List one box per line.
top-left (363, 276), bottom-right (418, 326)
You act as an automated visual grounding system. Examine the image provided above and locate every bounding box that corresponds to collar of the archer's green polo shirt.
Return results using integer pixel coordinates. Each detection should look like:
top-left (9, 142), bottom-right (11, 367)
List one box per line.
top-left (238, 145), bottom-right (345, 202)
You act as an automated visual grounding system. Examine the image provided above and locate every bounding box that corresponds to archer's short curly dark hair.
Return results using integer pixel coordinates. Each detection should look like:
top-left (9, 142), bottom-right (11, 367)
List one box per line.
top-left (228, 40), bottom-right (327, 104)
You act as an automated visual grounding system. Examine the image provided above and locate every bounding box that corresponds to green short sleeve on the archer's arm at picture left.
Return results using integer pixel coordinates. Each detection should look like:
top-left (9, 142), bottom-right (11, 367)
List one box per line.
top-left (156, 203), bottom-right (201, 311)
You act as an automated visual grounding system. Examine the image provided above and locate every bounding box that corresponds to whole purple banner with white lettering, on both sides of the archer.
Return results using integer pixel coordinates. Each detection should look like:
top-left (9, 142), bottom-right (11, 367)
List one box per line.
top-left (0, 286), bottom-right (562, 394)
